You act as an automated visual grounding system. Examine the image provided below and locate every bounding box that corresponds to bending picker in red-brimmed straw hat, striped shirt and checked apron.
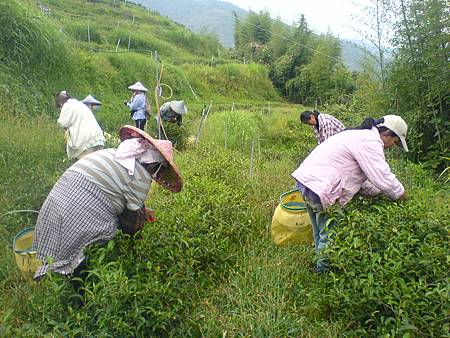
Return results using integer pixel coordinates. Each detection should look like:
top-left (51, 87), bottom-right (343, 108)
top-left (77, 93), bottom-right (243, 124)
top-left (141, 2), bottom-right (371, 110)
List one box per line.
top-left (33, 126), bottom-right (182, 280)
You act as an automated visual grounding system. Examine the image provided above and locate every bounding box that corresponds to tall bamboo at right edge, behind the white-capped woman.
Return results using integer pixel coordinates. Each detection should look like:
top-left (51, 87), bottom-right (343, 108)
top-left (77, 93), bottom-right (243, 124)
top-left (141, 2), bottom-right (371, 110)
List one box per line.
top-left (389, 0), bottom-right (450, 170)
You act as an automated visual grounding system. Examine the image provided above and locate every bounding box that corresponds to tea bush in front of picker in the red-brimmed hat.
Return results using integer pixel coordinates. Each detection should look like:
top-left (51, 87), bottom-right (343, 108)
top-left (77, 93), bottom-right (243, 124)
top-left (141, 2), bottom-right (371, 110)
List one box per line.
top-left (3, 148), bottom-right (270, 337)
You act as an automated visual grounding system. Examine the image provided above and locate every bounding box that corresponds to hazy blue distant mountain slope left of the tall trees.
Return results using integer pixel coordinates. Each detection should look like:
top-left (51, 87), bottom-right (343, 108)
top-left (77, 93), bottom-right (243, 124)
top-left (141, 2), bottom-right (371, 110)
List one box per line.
top-left (133, 0), bottom-right (247, 47)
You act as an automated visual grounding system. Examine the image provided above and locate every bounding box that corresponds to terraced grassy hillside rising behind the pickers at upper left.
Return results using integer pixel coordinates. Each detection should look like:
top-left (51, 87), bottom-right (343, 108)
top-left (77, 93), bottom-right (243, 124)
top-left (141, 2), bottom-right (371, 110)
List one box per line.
top-left (0, 0), bottom-right (280, 124)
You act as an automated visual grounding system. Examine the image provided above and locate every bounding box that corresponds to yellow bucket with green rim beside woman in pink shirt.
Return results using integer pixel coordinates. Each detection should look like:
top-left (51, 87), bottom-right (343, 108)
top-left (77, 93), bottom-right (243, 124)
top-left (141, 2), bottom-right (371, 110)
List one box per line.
top-left (270, 189), bottom-right (313, 246)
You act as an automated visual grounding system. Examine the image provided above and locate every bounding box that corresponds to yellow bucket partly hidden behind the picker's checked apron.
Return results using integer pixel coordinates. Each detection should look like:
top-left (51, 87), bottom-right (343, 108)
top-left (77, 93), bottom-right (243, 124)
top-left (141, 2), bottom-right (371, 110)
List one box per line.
top-left (13, 227), bottom-right (42, 273)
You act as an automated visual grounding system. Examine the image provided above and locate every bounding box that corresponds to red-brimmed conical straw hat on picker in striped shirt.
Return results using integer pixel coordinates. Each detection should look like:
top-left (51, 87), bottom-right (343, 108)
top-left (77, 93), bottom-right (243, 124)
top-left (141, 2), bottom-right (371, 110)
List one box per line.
top-left (119, 125), bottom-right (183, 192)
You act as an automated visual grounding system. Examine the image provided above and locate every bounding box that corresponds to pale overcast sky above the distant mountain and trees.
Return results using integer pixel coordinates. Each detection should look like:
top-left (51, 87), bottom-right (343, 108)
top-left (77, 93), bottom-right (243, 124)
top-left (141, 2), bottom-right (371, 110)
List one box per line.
top-left (224, 0), bottom-right (368, 39)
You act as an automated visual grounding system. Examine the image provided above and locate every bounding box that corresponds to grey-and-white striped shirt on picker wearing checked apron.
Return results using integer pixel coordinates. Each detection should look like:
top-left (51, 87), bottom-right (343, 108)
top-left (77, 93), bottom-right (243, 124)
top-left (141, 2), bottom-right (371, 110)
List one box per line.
top-left (68, 149), bottom-right (152, 214)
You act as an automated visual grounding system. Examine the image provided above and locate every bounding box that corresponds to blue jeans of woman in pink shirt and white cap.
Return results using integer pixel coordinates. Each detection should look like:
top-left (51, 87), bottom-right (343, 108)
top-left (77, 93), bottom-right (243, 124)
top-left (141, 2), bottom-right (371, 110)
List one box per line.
top-left (305, 199), bottom-right (335, 272)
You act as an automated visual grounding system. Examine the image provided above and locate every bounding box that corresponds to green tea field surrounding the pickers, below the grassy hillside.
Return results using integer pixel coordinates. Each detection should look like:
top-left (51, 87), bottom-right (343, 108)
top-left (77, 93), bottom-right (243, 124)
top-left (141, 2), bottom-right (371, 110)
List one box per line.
top-left (0, 103), bottom-right (449, 337)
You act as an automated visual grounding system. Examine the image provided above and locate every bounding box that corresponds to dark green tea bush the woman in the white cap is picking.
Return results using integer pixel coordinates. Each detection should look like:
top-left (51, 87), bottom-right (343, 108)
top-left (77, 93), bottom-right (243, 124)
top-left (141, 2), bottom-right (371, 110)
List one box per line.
top-left (324, 162), bottom-right (450, 337)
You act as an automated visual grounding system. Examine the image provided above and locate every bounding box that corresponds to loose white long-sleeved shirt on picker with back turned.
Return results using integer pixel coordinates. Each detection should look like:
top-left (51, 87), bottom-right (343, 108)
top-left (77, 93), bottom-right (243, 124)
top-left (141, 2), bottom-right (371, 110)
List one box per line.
top-left (58, 99), bottom-right (105, 159)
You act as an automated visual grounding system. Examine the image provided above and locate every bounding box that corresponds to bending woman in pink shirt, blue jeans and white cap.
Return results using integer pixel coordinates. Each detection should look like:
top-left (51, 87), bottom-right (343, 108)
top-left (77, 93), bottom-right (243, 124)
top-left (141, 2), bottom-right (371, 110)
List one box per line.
top-left (292, 115), bottom-right (408, 272)
